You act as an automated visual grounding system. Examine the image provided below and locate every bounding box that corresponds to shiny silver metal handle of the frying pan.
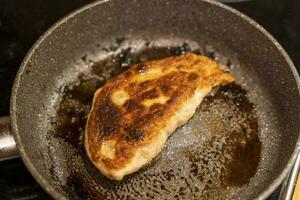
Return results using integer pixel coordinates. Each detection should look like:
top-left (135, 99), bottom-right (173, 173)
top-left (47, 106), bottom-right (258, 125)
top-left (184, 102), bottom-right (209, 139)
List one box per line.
top-left (0, 116), bottom-right (19, 161)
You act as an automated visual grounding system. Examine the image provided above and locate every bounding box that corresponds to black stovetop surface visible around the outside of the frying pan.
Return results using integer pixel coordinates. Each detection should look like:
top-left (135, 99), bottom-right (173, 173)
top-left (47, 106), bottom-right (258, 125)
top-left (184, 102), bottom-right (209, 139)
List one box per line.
top-left (0, 0), bottom-right (300, 200)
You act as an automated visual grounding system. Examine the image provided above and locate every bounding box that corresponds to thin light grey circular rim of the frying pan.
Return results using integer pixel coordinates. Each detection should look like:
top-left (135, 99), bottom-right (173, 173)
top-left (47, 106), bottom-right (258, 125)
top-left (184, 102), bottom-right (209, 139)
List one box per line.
top-left (10, 0), bottom-right (300, 200)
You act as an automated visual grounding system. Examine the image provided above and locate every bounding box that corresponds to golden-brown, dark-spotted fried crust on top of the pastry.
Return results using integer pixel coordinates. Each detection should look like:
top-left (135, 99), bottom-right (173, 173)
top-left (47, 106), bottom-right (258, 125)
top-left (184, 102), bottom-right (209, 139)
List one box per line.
top-left (86, 53), bottom-right (234, 170)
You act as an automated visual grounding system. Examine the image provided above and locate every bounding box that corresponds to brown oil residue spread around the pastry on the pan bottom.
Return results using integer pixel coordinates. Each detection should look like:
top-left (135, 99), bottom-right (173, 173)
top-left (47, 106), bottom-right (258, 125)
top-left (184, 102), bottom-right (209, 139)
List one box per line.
top-left (53, 44), bottom-right (261, 199)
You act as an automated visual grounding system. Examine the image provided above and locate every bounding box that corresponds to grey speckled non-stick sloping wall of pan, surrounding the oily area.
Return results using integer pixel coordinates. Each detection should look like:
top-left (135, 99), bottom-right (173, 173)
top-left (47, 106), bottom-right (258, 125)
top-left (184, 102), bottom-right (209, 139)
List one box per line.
top-left (11, 0), bottom-right (300, 199)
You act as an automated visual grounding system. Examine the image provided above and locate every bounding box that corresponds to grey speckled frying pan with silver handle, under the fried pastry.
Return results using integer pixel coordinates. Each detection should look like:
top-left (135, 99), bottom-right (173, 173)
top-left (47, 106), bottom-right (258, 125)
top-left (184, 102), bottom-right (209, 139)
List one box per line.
top-left (0, 0), bottom-right (300, 199)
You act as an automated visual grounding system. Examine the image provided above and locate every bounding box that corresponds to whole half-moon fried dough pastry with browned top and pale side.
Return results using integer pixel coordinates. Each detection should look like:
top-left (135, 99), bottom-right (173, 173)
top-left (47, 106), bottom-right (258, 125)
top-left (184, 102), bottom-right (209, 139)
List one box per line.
top-left (85, 53), bottom-right (234, 181)
